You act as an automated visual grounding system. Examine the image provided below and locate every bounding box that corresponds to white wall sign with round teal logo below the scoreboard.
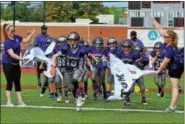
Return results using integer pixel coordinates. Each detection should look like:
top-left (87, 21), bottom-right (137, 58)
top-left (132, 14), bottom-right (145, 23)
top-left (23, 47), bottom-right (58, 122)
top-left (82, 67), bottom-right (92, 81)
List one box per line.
top-left (127, 29), bottom-right (184, 47)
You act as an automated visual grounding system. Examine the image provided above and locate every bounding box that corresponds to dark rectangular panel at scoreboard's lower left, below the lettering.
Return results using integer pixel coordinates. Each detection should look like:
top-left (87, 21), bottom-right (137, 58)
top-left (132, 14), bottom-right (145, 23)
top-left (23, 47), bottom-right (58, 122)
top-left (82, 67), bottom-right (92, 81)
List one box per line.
top-left (131, 17), bottom-right (144, 27)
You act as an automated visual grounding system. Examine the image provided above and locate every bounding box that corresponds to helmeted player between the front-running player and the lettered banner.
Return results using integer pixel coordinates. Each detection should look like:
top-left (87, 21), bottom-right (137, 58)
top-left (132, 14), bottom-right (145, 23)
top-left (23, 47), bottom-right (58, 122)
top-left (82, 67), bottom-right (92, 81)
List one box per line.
top-left (89, 37), bottom-right (107, 101)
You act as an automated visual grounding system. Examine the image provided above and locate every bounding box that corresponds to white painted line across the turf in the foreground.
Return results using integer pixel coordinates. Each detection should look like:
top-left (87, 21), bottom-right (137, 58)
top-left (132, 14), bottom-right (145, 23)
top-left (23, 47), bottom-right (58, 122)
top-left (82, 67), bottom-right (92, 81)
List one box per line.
top-left (1, 105), bottom-right (184, 114)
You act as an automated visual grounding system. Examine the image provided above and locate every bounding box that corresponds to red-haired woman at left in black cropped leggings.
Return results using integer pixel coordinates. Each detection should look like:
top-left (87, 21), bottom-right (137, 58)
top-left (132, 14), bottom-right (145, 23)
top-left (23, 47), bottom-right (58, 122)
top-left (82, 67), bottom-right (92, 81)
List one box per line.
top-left (3, 24), bottom-right (35, 106)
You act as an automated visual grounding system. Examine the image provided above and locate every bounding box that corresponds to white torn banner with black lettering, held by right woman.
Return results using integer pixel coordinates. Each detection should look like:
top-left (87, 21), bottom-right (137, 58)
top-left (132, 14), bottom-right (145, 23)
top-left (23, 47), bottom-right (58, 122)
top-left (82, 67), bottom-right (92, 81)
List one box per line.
top-left (108, 54), bottom-right (155, 100)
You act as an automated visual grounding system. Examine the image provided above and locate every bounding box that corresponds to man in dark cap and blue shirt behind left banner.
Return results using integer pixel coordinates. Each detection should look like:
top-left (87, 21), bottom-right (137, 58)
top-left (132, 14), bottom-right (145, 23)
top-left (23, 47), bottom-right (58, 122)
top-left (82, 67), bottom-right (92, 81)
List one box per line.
top-left (34, 25), bottom-right (50, 87)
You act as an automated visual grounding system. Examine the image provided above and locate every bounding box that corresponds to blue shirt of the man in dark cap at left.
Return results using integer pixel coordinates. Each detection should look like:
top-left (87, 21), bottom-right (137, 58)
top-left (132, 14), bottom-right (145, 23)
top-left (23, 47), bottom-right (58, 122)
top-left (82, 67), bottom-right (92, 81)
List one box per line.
top-left (34, 33), bottom-right (50, 52)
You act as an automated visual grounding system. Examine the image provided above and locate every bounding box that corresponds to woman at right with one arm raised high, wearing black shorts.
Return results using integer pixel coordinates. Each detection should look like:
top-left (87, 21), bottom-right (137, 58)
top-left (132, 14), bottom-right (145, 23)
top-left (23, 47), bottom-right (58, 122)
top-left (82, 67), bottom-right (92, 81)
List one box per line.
top-left (151, 15), bottom-right (184, 112)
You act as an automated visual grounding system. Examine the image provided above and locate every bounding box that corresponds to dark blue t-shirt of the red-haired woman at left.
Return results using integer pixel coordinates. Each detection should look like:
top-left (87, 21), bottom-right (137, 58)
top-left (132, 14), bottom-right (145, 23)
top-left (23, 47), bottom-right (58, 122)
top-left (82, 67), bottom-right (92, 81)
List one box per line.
top-left (3, 35), bottom-right (23, 64)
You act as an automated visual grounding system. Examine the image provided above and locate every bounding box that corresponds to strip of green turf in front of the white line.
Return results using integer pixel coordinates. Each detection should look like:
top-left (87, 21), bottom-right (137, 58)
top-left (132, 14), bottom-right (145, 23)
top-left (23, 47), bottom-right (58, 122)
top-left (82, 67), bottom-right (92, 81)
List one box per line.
top-left (1, 108), bottom-right (184, 124)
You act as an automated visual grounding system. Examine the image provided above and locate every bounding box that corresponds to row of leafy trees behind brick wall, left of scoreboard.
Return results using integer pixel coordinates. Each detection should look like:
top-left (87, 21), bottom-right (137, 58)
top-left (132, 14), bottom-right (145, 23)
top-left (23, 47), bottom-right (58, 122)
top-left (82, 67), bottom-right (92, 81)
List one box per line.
top-left (2, 1), bottom-right (110, 23)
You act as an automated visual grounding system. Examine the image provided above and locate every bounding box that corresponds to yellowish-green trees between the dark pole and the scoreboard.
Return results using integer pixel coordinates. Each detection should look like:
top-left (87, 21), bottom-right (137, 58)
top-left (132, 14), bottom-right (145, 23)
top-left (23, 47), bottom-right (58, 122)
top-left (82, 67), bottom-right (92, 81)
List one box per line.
top-left (46, 2), bottom-right (109, 22)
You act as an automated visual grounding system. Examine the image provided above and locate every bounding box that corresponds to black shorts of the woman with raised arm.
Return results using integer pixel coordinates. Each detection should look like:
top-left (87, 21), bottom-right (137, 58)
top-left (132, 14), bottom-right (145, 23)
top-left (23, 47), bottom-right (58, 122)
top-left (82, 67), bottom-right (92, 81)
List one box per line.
top-left (168, 68), bottom-right (184, 79)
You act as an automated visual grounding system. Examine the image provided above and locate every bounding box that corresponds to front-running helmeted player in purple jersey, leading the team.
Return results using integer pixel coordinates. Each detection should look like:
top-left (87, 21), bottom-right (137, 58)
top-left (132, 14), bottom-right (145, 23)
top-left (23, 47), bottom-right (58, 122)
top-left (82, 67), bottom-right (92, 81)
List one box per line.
top-left (50, 31), bottom-right (88, 108)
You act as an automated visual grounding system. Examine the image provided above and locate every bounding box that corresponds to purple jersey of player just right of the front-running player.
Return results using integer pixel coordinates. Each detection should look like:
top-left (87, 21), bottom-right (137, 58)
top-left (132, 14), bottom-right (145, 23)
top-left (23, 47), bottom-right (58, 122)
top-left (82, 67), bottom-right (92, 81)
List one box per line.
top-left (88, 46), bottom-right (107, 70)
